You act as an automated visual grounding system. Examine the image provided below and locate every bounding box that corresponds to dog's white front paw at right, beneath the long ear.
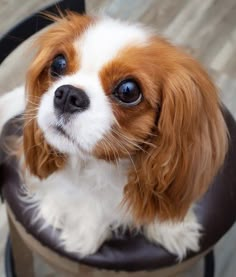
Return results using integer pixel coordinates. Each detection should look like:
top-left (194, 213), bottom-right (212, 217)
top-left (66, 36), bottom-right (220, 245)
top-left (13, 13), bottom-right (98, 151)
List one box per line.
top-left (145, 211), bottom-right (202, 261)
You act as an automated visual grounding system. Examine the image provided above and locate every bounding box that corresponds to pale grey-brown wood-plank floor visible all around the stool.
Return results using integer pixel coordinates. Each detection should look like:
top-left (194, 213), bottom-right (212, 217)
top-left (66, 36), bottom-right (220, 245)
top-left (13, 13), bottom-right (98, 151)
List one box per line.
top-left (0, 0), bottom-right (236, 277)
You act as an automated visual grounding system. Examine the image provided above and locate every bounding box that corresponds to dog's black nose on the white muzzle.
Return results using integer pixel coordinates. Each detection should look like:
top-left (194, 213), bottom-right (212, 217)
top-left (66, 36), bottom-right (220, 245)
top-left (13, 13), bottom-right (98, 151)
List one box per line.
top-left (54, 85), bottom-right (90, 113)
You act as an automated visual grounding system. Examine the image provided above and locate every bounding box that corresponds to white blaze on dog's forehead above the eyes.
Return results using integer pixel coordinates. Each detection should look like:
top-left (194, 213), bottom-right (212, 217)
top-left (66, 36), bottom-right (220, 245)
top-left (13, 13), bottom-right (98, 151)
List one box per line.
top-left (75, 18), bottom-right (149, 72)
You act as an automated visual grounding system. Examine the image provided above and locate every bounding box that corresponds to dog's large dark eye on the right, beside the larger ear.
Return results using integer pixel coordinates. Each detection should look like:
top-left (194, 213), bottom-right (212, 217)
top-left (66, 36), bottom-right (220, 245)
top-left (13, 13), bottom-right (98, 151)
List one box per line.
top-left (113, 80), bottom-right (142, 106)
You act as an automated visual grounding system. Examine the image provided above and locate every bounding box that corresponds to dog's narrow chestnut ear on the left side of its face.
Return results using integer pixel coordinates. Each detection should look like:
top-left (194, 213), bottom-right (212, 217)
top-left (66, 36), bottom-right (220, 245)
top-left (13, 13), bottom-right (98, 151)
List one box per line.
top-left (23, 48), bottom-right (64, 178)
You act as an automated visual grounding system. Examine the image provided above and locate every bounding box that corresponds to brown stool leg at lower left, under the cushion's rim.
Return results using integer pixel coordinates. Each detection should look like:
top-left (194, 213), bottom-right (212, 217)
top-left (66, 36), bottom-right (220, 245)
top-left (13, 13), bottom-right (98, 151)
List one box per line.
top-left (8, 213), bottom-right (34, 277)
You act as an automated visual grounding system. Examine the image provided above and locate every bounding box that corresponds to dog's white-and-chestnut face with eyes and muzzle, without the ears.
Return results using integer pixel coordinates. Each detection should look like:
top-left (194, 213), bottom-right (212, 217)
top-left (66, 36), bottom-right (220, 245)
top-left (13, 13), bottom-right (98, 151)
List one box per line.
top-left (37, 15), bottom-right (159, 157)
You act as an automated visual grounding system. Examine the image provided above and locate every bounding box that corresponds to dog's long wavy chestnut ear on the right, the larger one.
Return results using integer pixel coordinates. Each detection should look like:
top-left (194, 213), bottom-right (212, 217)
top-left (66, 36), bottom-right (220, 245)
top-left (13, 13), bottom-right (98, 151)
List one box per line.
top-left (125, 48), bottom-right (228, 223)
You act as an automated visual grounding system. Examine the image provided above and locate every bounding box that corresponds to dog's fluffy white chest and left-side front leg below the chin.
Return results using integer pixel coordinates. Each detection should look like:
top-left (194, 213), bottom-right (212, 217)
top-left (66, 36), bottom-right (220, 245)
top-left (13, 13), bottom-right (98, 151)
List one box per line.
top-left (23, 158), bottom-right (129, 255)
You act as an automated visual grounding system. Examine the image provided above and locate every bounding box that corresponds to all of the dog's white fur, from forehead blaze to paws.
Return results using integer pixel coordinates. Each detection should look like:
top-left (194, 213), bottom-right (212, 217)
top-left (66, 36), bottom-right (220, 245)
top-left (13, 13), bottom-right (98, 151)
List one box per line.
top-left (0, 19), bottom-right (201, 260)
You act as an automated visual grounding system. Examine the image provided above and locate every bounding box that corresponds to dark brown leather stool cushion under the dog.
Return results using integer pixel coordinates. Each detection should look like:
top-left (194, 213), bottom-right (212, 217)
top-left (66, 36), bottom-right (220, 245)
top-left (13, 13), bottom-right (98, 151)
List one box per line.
top-left (0, 108), bottom-right (236, 271)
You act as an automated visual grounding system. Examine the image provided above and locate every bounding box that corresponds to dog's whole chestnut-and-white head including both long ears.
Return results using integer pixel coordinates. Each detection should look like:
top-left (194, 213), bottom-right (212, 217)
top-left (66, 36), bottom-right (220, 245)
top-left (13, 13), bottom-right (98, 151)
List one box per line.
top-left (24, 14), bottom-right (227, 221)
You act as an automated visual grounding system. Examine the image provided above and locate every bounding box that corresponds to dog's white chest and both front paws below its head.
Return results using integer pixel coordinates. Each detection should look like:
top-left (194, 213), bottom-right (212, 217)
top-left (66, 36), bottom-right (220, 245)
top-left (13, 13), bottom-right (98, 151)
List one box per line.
top-left (23, 159), bottom-right (201, 260)
